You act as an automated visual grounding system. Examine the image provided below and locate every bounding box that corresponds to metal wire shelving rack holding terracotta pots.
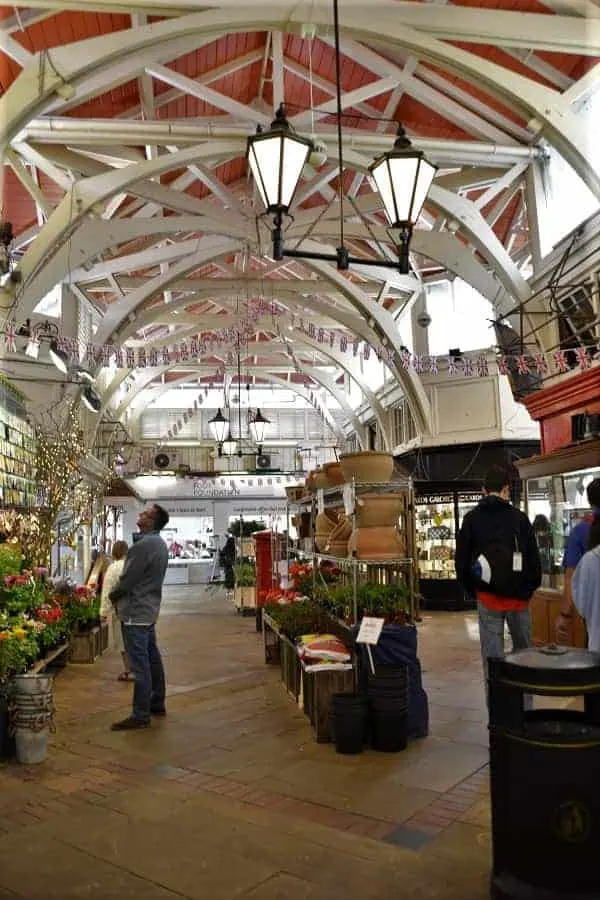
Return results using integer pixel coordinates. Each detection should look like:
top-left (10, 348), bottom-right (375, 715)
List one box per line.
top-left (286, 479), bottom-right (418, 623)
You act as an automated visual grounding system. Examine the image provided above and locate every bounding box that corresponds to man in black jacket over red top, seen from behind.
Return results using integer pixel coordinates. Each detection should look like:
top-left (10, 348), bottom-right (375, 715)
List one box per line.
top-left (455, 466), bottom-right (542, 700)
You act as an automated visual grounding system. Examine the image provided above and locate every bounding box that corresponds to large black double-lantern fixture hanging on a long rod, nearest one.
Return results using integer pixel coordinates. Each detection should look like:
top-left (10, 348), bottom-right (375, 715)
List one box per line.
top-left (246, 0), bottom-right (437, 274)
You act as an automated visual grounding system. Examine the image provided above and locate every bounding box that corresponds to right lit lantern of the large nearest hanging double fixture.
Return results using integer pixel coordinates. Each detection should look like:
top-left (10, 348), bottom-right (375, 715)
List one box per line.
top-left (369, 125), bottom-right (437, 275)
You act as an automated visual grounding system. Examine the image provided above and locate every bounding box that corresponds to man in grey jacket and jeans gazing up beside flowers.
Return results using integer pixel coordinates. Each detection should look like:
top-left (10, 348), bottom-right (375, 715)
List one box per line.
top-left (110, 504), bottom-right (169, 731)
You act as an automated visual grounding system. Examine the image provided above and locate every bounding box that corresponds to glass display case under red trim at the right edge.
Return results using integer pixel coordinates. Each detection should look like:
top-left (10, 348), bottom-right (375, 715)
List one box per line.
top-left (525, 466), bottom-right (600, 591)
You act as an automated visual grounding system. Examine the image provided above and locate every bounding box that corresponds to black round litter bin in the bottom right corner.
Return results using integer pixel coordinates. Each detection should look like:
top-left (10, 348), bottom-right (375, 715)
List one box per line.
top-left (488, 647), bottom-right (600, 900)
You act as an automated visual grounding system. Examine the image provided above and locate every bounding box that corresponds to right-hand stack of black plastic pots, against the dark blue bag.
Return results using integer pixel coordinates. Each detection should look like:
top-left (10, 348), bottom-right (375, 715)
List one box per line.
top-left (367, 665), bottom-right (408, 753)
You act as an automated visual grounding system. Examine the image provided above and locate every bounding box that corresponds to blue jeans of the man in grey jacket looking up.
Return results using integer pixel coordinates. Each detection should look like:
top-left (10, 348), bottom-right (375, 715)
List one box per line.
top-left (121, 625), bottom-right (165, 722)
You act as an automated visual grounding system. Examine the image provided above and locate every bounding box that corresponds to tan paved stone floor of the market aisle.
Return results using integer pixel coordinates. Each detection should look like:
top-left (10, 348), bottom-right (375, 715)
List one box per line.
top-left (0, 587), bottom-right (490, 900)
